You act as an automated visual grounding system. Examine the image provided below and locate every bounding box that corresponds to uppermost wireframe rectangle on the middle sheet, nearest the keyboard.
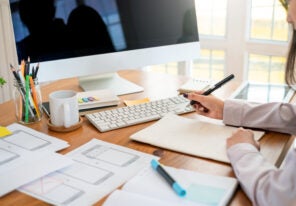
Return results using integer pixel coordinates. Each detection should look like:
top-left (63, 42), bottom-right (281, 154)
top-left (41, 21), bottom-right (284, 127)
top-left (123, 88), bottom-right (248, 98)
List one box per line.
top-left (82, 145), bottom-right (139, 167)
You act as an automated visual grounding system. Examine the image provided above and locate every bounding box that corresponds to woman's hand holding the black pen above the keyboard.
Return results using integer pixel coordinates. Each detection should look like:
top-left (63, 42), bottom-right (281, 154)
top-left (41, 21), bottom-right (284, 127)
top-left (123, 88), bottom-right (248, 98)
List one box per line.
top-left (185, 92), bottom-right (224, 119)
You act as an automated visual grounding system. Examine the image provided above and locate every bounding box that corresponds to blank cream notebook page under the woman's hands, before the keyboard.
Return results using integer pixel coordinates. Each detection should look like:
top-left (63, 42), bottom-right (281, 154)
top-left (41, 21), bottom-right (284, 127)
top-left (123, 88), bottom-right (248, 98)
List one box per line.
top-left (130, 114), bottom-right (264, 163)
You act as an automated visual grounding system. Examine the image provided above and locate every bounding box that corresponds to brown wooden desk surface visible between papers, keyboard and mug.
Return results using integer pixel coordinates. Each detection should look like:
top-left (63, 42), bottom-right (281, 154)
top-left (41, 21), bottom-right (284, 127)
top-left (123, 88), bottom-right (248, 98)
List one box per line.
top-left (0, 70), bottom-right (293, 206)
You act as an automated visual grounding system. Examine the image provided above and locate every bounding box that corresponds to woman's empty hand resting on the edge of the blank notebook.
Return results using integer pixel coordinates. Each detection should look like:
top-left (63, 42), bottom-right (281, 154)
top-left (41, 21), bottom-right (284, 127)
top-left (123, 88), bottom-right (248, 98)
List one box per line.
top-left (226, 128), bottom-right (260, 150)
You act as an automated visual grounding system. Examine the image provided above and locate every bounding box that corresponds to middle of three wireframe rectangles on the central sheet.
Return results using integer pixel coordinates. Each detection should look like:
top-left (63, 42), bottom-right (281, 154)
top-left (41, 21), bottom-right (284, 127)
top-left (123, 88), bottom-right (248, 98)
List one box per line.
top-left (58, 160), bottom-right (114, 185)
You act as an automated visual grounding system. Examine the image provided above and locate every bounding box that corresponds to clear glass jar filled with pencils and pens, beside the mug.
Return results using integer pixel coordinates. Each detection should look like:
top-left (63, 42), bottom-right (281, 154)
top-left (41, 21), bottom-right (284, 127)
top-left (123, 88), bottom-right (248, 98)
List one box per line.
top-left (14, 76), bottom-right (43, 124)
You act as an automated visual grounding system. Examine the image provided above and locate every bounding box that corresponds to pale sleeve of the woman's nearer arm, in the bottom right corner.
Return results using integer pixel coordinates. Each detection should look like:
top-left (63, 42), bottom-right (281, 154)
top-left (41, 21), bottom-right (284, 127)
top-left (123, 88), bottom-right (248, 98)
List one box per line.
top-left (227, 143), bottom-right (296, 206)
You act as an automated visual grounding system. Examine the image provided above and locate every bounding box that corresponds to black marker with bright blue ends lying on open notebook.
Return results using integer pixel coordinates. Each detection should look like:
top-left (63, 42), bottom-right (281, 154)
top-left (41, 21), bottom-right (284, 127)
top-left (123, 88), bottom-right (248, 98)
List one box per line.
top-left (151, 159), bottom-right (186, 197)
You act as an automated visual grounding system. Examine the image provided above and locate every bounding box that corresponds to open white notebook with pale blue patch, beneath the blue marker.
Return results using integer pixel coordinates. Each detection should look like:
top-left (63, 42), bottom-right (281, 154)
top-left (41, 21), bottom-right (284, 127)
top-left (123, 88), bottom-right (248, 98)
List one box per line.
top-left (104, 167), bottom-right (238, 206)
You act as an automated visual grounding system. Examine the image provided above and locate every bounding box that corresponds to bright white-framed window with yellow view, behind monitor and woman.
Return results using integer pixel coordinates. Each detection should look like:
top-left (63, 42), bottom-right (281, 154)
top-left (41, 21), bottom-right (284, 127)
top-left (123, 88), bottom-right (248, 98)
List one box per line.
top-left (147, 0), bottom-right (289, 86)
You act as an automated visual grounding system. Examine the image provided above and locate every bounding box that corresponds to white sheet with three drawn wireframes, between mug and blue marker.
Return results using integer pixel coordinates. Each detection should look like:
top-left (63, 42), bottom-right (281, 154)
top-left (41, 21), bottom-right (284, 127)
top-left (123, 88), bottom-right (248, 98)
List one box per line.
top-left (19, 139), bottom-right (156, 206)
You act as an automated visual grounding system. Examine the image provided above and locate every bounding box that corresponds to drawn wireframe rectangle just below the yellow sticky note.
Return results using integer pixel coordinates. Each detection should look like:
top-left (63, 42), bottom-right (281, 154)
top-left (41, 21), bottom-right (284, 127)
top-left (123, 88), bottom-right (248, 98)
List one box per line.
top-left (3, 130), bottom-right (50, 151)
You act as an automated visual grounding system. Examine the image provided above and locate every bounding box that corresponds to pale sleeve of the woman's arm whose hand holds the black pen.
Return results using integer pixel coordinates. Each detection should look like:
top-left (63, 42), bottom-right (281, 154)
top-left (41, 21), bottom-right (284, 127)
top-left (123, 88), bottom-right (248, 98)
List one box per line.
top-left (223, 99), bottom-right (296, 134)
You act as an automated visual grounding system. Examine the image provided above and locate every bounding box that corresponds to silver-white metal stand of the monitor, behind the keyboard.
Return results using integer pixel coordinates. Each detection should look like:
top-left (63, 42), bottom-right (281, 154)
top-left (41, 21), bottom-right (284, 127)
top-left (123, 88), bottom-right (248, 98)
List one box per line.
top-left (78, 73), bottom-right (144, 95)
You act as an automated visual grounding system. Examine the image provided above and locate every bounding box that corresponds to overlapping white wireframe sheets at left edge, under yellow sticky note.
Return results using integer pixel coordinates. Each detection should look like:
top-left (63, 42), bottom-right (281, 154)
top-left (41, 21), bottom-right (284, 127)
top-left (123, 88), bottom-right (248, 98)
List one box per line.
top-left (0, 124), bottom-right (73, 196)
